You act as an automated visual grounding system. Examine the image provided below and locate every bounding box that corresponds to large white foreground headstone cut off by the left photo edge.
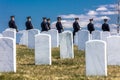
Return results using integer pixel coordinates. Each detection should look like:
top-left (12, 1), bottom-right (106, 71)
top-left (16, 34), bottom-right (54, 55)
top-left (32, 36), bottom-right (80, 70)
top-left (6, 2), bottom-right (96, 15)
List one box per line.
top-left (0, 37), bottom-right (16, 72)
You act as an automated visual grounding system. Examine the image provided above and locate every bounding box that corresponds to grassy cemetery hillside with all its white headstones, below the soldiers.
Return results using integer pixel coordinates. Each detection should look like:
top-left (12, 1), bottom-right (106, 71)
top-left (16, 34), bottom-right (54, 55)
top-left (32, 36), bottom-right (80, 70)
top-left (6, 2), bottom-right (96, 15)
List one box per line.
top-left (0, 28), bottom-right (120, 80)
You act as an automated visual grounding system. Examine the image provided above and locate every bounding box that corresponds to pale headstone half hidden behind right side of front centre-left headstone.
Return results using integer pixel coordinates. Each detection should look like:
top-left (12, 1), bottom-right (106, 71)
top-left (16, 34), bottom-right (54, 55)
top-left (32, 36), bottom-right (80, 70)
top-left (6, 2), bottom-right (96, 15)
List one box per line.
top-left (42, 29), bottom-right (59, 48)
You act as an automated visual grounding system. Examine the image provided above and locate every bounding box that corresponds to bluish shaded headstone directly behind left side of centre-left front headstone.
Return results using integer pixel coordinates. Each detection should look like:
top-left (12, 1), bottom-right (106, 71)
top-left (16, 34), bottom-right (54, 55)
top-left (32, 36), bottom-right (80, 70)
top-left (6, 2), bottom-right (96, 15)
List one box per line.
top-left (28, 29), bottom-right (40, 49)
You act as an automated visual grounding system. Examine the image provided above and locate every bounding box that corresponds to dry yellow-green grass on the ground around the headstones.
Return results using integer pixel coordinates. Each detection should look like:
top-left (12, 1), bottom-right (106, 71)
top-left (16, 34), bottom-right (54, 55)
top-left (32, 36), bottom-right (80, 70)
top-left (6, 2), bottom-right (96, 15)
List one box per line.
top-left (0, 45), bottom-right (120, 80)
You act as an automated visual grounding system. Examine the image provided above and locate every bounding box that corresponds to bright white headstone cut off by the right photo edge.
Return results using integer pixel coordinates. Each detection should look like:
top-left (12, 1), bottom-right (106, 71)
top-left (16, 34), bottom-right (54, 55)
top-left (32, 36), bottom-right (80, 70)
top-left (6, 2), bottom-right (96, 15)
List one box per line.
top-left (107, 36), bottom-right (120, 65)
